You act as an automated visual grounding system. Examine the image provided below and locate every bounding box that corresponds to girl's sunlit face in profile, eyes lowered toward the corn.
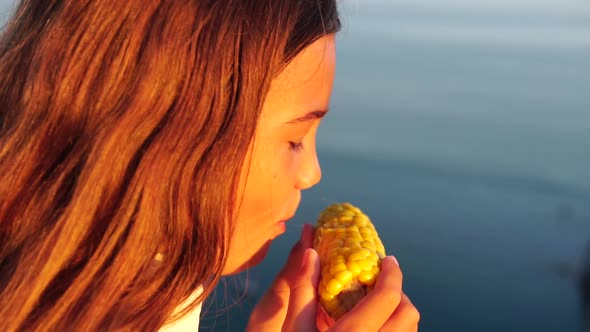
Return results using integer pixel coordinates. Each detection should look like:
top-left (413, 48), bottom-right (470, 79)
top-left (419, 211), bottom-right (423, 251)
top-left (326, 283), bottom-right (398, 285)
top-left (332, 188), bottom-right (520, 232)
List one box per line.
top-left (223, 35), bottom-right (336, 274)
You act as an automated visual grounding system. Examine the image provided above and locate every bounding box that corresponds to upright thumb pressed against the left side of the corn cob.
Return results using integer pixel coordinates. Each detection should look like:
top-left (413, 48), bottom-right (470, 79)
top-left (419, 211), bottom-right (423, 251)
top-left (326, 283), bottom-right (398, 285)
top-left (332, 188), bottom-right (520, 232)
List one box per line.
top-left (283, 248), bottom-right (320, 331)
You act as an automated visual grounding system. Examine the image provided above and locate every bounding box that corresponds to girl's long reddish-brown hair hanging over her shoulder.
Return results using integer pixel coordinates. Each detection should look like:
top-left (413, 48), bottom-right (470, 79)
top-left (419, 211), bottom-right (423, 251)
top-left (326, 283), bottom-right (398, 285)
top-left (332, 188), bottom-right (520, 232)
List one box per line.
top-left (0, 0), bottom-right (340, 331)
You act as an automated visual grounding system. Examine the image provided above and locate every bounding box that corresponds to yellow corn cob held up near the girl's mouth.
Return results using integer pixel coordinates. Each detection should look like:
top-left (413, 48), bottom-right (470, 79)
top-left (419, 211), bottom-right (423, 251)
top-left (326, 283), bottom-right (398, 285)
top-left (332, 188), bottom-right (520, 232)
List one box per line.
top-left (313, 203), bottom-right (385, 320)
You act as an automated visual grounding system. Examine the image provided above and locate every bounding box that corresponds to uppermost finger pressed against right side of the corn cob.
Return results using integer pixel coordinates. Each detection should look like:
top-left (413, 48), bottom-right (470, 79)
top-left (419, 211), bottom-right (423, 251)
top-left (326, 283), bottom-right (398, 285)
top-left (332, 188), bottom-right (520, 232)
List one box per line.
top-left (334, 256), bottom-right (402, 331)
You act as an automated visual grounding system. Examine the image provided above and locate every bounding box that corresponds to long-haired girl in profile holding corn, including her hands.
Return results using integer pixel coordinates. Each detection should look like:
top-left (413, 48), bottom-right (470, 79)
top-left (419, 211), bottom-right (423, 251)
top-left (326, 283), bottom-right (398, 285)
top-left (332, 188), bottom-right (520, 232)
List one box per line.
top-left (0, 0), bottom-right (418, 331)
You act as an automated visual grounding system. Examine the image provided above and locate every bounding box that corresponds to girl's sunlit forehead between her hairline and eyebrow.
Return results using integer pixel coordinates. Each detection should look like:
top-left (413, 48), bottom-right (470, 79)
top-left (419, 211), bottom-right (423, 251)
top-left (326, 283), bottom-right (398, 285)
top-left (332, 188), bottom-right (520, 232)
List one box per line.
top-left (262, 35), bottom-right (336, 122)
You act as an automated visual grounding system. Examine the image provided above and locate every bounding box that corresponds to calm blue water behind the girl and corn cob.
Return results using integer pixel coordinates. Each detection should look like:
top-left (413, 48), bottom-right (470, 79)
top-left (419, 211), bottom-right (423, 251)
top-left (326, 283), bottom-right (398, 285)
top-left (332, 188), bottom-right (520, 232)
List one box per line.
top-left (0, 0), bottom-right (590, 332)
